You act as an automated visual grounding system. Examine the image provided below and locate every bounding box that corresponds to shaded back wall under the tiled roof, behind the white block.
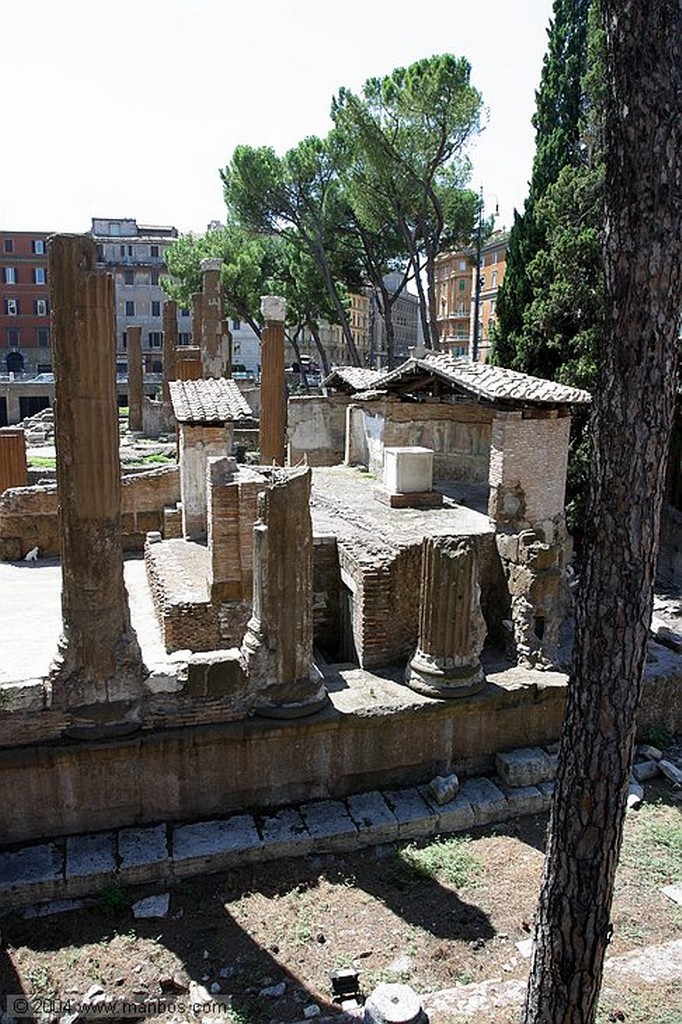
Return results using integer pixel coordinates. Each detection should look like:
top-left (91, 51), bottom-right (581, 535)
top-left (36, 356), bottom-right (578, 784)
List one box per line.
top-left (346, 399), bottom-right (493, 483)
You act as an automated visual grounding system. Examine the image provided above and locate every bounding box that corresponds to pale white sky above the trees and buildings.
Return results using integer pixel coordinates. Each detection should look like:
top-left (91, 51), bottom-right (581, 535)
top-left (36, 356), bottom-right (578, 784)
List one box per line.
top-left (0, 0), bottom-right (552, 232)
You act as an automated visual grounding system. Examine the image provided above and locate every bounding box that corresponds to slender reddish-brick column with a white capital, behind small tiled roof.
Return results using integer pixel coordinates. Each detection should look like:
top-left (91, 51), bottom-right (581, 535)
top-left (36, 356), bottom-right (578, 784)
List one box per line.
top-left (259, 295), bottom-right (287, 466)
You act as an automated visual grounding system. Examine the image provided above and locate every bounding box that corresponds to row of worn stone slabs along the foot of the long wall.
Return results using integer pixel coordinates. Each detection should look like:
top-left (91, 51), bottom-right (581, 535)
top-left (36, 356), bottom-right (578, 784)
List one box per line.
top-left (0, 749), bottom-right (553, 907)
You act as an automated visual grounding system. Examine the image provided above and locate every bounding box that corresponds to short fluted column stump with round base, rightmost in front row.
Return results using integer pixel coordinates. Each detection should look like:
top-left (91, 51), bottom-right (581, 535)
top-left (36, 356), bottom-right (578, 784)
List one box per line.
top-left (406, 537), bottom-right (486, 697)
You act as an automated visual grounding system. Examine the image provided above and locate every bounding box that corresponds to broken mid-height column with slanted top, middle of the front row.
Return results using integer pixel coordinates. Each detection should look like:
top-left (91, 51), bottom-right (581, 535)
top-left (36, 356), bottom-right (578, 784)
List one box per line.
top-left (242, 467), bottom-right (327, 718)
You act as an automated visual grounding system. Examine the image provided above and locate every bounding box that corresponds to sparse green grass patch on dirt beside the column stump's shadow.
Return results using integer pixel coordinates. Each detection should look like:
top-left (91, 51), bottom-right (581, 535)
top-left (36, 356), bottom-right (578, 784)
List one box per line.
top-left (386, 836), bottom-right (483, 889)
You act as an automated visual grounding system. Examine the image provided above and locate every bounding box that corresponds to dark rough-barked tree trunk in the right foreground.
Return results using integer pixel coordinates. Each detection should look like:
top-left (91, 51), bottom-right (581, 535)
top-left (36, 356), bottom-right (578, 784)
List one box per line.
top-left (524, 0), bottom-right (682, 1024)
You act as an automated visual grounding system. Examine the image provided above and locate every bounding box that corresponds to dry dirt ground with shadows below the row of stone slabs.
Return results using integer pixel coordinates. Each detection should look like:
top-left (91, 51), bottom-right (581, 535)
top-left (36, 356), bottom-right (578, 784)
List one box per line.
top-left (0, 782), bottom-right (682, 1024)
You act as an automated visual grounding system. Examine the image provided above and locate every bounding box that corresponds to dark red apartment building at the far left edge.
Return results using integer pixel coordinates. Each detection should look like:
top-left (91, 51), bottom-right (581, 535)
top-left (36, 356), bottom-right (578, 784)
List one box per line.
top-left (0, 231), bottom-right (52, 375)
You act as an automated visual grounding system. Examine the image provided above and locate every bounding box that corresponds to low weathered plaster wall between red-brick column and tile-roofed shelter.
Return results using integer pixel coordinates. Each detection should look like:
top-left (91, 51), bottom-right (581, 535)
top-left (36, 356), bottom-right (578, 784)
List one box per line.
top-left (287, 394), bottom-right (352, 466)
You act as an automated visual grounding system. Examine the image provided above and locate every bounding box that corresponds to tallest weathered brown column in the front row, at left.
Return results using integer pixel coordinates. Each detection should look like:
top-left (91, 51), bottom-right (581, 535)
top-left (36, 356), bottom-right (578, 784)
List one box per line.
top-left (47, 234), bottom-right (143, 716)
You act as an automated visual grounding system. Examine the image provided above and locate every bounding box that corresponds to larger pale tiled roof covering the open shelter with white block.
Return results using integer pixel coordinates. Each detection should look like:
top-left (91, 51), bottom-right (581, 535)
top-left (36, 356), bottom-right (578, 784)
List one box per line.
top-left (372, 352), bottom-right (592, 406)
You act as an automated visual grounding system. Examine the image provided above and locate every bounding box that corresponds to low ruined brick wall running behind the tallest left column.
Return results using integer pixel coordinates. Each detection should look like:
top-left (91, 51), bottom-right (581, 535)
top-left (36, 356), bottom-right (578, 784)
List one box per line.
top-left (0, 466), bottom-right (180, 561)
